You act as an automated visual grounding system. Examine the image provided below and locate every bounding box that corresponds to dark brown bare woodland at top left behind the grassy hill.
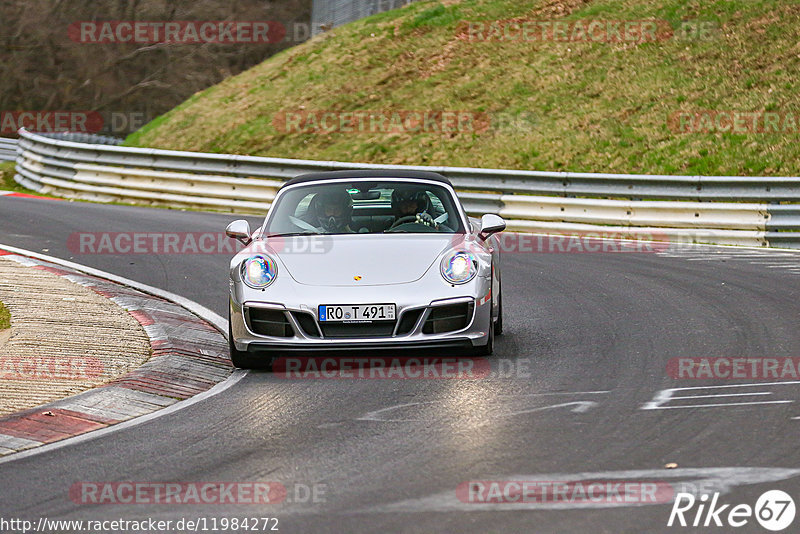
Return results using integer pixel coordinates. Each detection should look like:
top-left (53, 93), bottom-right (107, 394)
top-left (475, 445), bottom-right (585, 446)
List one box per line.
top-left (0, 0), bottom-right (311, 136)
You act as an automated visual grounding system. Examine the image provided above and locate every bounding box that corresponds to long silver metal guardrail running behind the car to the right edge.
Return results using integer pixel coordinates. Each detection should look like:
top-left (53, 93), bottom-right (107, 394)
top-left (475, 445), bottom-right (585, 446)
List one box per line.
top-left (10, 130), bottom-right (800, 248)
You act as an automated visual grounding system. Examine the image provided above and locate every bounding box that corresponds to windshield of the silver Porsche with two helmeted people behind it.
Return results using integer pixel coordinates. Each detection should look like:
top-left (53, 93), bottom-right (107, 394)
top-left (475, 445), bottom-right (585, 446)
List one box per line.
top-left (264, 180), bottom-right (464, 236)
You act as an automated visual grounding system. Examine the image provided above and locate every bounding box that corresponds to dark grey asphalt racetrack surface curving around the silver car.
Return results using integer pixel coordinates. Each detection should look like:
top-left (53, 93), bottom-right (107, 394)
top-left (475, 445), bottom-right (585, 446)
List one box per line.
top-left (0, 198), bottom-right (800, 533)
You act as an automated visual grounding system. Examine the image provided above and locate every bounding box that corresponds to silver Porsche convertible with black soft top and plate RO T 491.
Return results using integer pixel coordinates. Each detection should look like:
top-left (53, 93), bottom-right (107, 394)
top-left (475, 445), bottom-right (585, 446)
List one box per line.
top-left (226, 171), bottom-right (506, 368)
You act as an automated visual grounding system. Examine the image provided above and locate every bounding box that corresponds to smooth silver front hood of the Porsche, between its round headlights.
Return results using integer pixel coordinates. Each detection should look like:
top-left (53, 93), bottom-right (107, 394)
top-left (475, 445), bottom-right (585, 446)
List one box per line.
top-left (256, 234), bottom-right (456, 286)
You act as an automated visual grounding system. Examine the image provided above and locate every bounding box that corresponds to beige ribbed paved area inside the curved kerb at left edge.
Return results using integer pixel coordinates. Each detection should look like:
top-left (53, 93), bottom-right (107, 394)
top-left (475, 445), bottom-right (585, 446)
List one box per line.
top-left (0, 258), bottom-right (150, 415)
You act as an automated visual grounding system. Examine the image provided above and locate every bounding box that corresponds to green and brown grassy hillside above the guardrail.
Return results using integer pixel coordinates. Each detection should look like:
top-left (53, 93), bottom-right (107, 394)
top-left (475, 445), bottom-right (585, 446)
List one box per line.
top-left (127, 0), bottom-right (800, 175)
